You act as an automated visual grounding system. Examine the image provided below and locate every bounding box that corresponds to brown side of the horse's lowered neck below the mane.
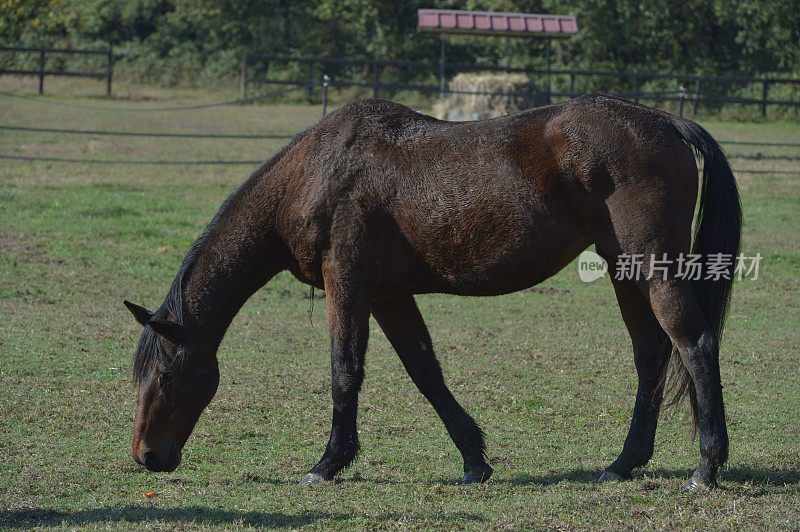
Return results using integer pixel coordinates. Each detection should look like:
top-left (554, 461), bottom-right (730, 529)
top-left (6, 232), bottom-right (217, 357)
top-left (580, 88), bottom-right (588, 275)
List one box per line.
top-left (183, 181), bottom-right (286, 342)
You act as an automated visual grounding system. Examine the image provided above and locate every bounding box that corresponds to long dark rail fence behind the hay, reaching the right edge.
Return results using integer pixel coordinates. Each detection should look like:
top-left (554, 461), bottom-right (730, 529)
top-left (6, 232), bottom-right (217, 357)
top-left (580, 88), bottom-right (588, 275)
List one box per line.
top-left (241, 53), bottom-right (800, 116)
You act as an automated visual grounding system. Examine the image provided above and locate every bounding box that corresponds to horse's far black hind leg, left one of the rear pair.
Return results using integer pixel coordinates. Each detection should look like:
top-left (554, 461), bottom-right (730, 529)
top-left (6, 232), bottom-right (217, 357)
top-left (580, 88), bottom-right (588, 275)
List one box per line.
top-left (600, 274), bottom-right (672, 482)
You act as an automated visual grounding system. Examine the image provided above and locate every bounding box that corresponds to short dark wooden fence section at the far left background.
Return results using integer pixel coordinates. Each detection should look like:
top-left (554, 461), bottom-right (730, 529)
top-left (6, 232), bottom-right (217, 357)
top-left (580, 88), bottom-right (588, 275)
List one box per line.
top-left (0, 46), bottom-right (114, 96)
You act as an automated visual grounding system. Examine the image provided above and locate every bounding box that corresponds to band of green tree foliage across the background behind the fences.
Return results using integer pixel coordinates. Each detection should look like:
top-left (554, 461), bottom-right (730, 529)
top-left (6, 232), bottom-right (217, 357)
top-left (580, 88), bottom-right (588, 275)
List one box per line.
top-left (0, 0), bottom-right (800, 89)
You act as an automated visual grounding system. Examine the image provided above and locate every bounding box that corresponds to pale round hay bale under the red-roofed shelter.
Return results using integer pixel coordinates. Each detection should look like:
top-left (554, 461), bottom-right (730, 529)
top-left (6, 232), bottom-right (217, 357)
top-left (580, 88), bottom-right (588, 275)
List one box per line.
top-left (433, 72), bottom-right (544, 120)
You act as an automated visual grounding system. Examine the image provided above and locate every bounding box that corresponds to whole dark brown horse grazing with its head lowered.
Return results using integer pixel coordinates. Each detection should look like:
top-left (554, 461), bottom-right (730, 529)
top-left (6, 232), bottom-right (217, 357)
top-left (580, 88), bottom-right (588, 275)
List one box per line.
top-left (126, 96), bottom-right (741, 490)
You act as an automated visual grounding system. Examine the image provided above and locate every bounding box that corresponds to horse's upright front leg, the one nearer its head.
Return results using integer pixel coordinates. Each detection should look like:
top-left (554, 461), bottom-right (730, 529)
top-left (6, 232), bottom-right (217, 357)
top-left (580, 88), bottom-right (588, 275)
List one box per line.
top-left (300, 268), bottom-right (369, 484)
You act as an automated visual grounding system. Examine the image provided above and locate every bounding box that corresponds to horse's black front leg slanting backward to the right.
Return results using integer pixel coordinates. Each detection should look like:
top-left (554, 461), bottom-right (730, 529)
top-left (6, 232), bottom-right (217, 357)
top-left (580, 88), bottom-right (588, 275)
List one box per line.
top-left (372, 295), bottom-right (492, 484)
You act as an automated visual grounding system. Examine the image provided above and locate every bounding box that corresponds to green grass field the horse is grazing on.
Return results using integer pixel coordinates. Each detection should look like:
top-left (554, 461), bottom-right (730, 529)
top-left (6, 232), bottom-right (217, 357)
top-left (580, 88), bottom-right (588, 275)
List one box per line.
top-left (0, 89), bottom-right (800, 530)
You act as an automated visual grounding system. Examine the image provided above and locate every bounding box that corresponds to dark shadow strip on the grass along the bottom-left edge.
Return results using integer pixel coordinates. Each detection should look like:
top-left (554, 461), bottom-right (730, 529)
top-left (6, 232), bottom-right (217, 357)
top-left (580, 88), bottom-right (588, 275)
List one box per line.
top-left (0, 505), bottom-right (483, 530)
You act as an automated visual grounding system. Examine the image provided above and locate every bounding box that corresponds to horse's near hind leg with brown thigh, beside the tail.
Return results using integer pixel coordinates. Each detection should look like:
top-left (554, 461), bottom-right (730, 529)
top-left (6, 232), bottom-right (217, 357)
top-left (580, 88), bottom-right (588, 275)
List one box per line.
top-left (594, 162), bottom-right (728, 490)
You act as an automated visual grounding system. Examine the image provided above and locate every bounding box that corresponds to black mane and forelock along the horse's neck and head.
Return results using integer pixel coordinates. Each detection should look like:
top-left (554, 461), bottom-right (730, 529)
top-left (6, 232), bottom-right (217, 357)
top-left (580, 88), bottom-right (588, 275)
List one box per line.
top-left (133, 128), bottom-right (312, 384)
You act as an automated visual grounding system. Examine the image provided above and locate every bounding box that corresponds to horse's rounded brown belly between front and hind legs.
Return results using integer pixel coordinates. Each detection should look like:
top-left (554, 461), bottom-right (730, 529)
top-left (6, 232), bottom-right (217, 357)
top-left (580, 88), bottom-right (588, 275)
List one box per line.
top-left (379, 206), bottom-right (590, 295)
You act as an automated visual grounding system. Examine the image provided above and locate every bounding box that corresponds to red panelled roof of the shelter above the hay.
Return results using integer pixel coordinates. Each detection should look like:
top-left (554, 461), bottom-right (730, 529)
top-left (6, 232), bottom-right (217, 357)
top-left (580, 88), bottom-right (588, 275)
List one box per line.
top-left (417, 9), bottom-right (578, 38)
